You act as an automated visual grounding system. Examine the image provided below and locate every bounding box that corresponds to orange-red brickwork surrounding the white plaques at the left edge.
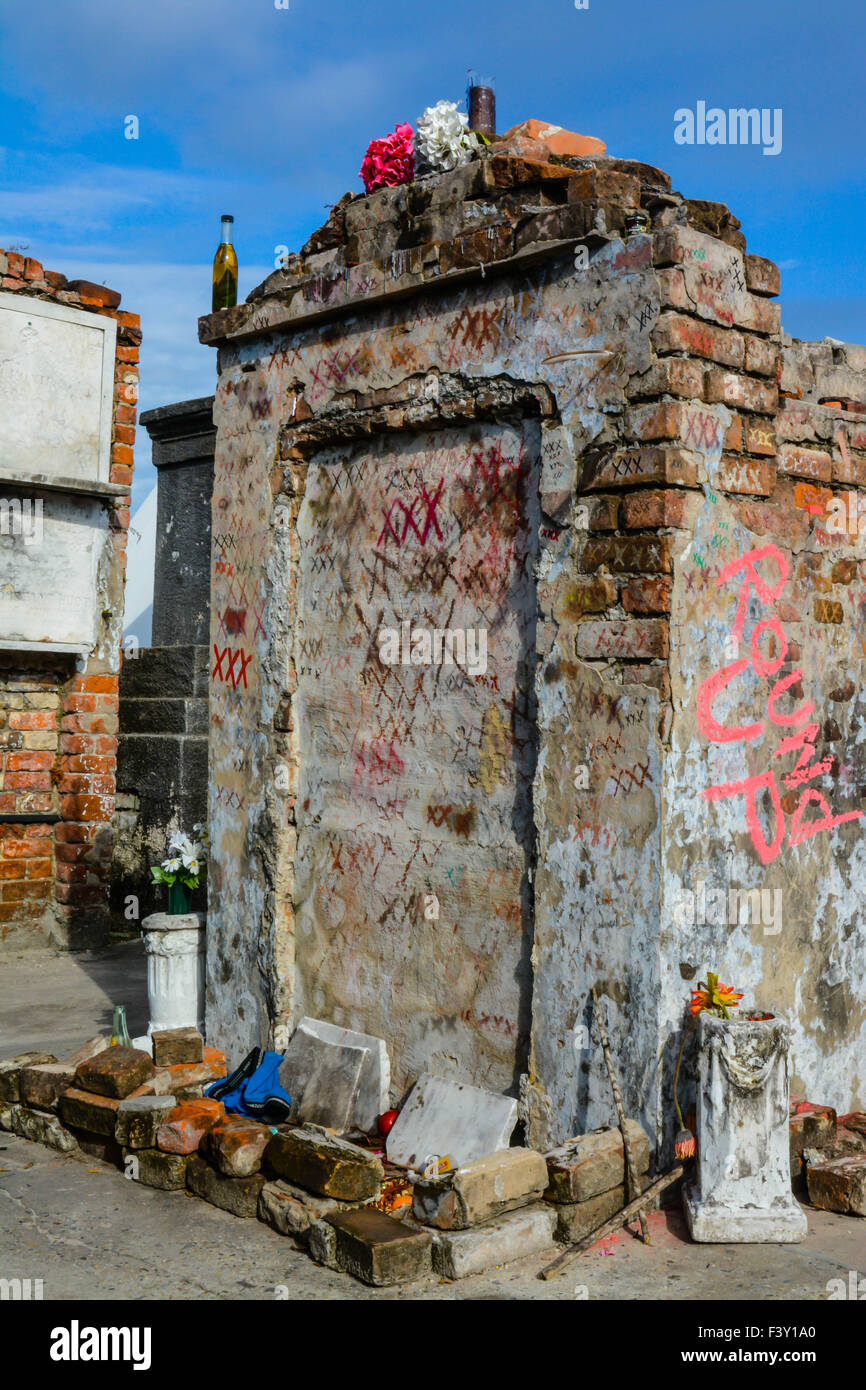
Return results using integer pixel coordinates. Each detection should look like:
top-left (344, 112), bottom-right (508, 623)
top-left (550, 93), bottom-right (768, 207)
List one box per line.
top-left (0, 250), bottom-right (142, 949)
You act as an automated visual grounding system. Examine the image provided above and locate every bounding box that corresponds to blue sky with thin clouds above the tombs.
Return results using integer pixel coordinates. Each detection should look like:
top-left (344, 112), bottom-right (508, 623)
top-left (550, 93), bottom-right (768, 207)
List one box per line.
top-left (0, 0), bottom-right (866, 519)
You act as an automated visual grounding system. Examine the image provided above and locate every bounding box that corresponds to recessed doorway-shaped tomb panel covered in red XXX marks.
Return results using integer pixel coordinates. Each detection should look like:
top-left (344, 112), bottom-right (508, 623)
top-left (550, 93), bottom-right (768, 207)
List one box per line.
top-left (293, 420), bottom-right (539, 1090)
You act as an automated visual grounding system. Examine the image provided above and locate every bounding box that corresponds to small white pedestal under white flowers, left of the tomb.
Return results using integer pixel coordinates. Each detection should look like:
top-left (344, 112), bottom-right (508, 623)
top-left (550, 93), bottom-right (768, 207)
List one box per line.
top-left (142, 912), bottom-right (207, 1037)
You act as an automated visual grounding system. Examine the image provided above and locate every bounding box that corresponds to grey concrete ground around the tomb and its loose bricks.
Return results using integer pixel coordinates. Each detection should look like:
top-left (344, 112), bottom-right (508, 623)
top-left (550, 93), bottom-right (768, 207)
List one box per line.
top-left (0, 942), bottom-right (866, 1302)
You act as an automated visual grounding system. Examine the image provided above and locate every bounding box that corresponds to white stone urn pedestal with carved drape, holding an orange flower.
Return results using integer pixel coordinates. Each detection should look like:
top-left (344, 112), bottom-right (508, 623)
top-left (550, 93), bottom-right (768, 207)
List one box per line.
top-left (684, 1011), bottom-right (806, 1243)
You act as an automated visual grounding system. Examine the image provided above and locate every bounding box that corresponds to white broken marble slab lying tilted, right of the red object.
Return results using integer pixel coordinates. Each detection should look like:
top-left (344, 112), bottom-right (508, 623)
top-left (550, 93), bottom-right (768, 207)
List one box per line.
top-left (385, 1072), bottom-right (517, 1169)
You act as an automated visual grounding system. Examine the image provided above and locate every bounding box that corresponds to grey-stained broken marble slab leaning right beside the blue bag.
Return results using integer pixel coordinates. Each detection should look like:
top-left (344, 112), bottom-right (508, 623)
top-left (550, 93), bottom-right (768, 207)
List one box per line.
top-left (278, 1022), bottom-right (370, 1134)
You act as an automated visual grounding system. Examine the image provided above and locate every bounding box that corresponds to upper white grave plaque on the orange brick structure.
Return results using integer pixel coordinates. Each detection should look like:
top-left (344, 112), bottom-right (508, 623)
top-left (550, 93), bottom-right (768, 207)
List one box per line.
top-left (0, 293), bottom-right (117, 482)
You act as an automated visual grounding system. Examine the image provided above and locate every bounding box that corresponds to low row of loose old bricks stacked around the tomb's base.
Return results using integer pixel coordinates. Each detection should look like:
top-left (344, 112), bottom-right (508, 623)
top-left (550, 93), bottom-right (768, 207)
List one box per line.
top-left (0, 1029), bottom-right (866, 1287)
